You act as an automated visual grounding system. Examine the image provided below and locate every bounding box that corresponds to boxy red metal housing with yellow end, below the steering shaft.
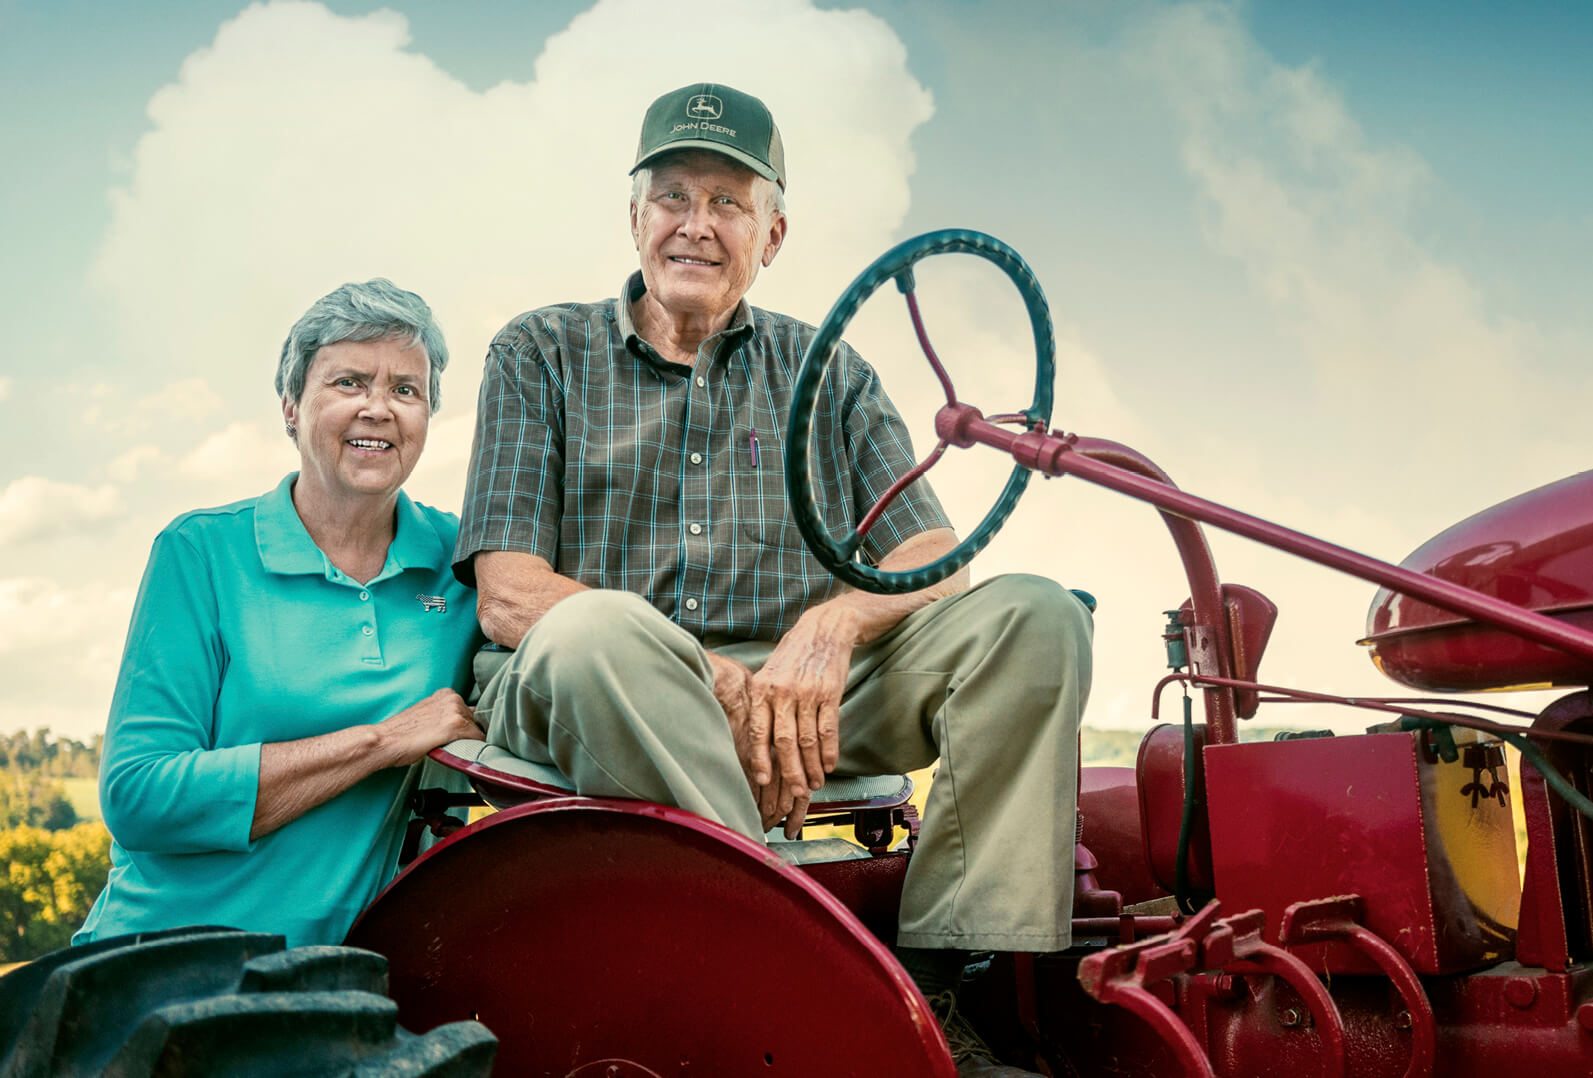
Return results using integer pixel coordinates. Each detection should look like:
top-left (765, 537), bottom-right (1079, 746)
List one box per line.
top-left (1204, 734), bottom-right (1520, 973)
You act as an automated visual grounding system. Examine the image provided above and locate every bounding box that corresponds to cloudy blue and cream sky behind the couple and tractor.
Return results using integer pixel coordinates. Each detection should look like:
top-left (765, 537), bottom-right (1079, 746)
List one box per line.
top-left (0, 0), bottom-right (1593, 739)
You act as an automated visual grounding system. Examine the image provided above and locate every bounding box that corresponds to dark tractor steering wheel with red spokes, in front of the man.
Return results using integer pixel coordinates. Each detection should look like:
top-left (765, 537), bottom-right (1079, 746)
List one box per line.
top-left (785, 228), bottom-right (1056, 594)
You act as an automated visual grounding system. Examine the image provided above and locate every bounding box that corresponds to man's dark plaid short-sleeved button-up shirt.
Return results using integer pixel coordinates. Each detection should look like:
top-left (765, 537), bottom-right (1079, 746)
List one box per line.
top-left (454, 272), bottom-right (949, 640)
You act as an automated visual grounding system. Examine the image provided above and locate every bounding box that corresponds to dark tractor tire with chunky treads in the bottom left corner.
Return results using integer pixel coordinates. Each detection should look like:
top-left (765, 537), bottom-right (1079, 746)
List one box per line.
top-left (0, 928), bottom-right (497, 1078)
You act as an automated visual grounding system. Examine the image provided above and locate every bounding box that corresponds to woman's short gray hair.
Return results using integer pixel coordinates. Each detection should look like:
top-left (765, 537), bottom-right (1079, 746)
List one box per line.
top-left (277, 277), bottom-right (448, 416)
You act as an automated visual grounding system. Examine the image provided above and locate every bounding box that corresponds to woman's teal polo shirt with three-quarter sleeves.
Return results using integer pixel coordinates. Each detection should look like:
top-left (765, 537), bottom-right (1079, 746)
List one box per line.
top-left (73, 473), bottom-right (481, 946)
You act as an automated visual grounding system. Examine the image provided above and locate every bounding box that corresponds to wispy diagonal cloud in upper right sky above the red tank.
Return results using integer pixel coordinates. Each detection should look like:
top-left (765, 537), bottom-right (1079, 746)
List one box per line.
top-left (1134, 5), bottom-right (1587, 497)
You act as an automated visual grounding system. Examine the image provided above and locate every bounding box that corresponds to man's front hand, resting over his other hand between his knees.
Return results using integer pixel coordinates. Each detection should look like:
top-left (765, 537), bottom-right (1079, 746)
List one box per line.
top-left (750, 603), bottom-right (857, 803)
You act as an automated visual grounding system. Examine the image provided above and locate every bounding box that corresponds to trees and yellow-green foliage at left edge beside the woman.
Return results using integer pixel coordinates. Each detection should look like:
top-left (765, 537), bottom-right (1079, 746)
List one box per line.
top-left (0, 729), bottom-right (110, 963)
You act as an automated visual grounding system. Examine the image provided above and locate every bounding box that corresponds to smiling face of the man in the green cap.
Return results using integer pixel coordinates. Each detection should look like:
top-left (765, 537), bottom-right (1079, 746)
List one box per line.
top-left (631, 151), bottom-right (785, 320)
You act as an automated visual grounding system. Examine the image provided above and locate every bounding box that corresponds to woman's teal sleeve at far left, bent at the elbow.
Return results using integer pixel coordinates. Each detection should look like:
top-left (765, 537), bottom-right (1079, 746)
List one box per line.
top-left (100, 529), bottom-right (260, 853)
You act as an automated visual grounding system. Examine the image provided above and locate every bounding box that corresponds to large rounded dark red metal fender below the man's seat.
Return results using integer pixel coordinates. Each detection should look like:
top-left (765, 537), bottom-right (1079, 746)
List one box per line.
top-left (349, 798), bottom-right (956, 1078)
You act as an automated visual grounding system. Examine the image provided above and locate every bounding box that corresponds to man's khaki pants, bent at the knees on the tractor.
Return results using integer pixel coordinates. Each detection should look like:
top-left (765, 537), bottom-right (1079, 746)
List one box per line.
top-left (476, 576), bottom-right (1091, 951)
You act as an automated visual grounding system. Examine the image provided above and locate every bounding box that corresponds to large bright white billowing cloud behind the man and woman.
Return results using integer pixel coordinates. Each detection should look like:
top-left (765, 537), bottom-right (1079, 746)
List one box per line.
top-left (0, 0), bottom-right (932, 734)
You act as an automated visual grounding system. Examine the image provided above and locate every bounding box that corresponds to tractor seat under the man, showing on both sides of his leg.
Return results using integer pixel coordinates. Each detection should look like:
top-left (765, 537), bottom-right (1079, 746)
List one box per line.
top-left (432, 739), bottom-right (913, 817)
